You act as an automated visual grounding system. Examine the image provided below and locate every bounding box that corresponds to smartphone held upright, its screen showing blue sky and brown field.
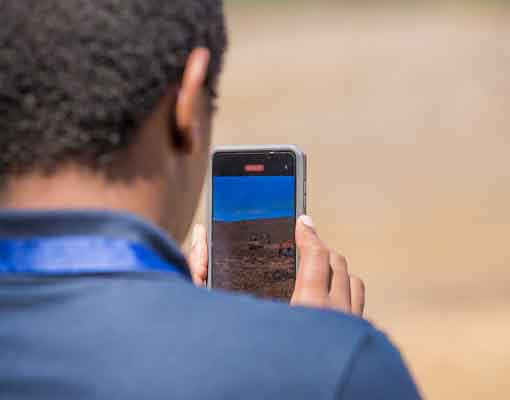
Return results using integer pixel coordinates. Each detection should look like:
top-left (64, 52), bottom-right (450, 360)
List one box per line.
top-left (208, 145), bottom-right (306, 301)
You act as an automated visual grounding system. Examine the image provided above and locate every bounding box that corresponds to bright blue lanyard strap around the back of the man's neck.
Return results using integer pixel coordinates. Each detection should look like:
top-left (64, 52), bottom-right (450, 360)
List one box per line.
top-left (0, 235), bottom-right (190, 280)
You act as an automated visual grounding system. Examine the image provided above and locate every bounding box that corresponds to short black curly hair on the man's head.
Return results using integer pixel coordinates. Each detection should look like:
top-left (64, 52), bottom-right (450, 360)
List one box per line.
top-left (0, 0), bottom-right (227, 180)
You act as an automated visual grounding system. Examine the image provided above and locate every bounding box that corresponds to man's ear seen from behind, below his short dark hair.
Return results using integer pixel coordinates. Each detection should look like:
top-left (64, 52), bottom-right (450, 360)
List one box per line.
top-left (171, 47), bottom-right (210, 154)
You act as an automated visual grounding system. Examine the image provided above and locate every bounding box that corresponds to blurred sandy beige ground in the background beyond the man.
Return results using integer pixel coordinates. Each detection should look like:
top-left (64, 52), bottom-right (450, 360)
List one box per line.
top-left (192, 2), bottom-right (510, 399)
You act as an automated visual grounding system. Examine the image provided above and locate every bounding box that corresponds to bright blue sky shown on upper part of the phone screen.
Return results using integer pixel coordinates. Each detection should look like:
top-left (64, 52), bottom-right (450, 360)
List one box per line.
top-left (213, 176), bottom-right (295, 222)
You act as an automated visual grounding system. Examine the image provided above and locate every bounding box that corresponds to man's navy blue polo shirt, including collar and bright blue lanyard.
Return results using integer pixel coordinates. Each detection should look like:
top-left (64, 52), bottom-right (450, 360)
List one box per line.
top-left (0, 211), bottom-right (419, 400)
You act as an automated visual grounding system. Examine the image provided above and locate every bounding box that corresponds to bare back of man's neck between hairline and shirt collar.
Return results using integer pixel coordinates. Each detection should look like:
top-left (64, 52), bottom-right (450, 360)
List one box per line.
top-left (0, 167), bottom-right (163, 225)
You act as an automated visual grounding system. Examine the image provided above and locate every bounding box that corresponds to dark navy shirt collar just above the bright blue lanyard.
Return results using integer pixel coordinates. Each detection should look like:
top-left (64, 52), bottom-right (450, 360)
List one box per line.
top-left (0, 210), bottom-right (189, 278)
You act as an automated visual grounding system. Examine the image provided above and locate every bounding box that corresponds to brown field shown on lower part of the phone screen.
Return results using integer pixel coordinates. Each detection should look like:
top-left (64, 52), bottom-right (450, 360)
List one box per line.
top-left (212, 218), bottom-right (296, 301)
